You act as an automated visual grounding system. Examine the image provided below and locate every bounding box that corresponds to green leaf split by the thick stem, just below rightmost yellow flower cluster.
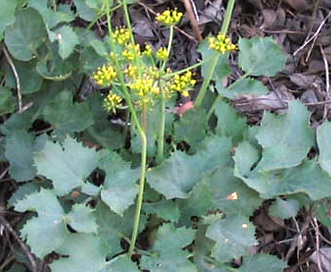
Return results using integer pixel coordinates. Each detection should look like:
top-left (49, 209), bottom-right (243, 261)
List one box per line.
top-left (198, 39), bottom-right (232, 82)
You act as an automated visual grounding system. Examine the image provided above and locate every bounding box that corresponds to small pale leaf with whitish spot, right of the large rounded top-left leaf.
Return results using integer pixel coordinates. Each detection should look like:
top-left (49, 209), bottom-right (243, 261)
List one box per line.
top-left (54, 25), bottom-right (79, 59)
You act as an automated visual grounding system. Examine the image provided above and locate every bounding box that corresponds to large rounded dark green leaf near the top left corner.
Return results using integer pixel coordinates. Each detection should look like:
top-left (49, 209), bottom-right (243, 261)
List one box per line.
top-left (5, 8), bottom-right (47, 61)
